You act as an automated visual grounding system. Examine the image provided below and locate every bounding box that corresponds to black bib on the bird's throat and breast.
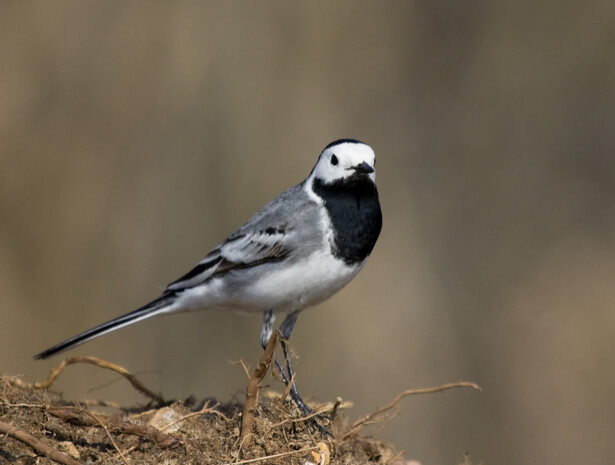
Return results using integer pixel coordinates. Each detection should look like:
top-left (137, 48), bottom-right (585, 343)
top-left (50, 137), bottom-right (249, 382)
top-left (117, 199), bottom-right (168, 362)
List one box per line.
top-left (312, 175), bottom-right (382, 265)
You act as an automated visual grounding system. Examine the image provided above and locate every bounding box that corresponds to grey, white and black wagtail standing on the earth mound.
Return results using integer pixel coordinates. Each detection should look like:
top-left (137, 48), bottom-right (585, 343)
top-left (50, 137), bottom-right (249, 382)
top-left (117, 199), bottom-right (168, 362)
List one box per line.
top-left (36, 139), bottom-right (382, 413)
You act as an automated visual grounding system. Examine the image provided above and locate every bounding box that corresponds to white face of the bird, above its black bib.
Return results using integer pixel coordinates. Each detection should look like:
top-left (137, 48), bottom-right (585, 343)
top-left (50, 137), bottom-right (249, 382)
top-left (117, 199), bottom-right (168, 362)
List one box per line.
top-left (308, 141), bottom-right (376, 184)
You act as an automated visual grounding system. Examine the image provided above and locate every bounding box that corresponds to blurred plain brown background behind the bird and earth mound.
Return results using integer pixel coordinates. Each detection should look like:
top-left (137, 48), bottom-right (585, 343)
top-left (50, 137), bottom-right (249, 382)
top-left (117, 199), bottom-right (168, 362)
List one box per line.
top-left (0, 1), bottom-right (615, 464)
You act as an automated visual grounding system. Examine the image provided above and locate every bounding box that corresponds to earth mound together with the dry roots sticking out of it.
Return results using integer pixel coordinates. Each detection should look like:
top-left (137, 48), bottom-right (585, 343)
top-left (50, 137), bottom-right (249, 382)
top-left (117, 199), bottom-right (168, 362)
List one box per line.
top-left (0, 352), bottom-right (480, 465)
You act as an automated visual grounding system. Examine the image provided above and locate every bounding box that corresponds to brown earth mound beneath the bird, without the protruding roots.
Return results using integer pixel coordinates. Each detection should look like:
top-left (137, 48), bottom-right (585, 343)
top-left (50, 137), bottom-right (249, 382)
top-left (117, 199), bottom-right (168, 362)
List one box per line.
top-left (0, 358), bottom-right (403, 465)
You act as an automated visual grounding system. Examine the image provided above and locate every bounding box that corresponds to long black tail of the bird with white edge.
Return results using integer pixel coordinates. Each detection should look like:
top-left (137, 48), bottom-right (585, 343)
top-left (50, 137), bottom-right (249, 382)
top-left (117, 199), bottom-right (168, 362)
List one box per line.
top-left (34, 294), bottom-right (175, 359)
